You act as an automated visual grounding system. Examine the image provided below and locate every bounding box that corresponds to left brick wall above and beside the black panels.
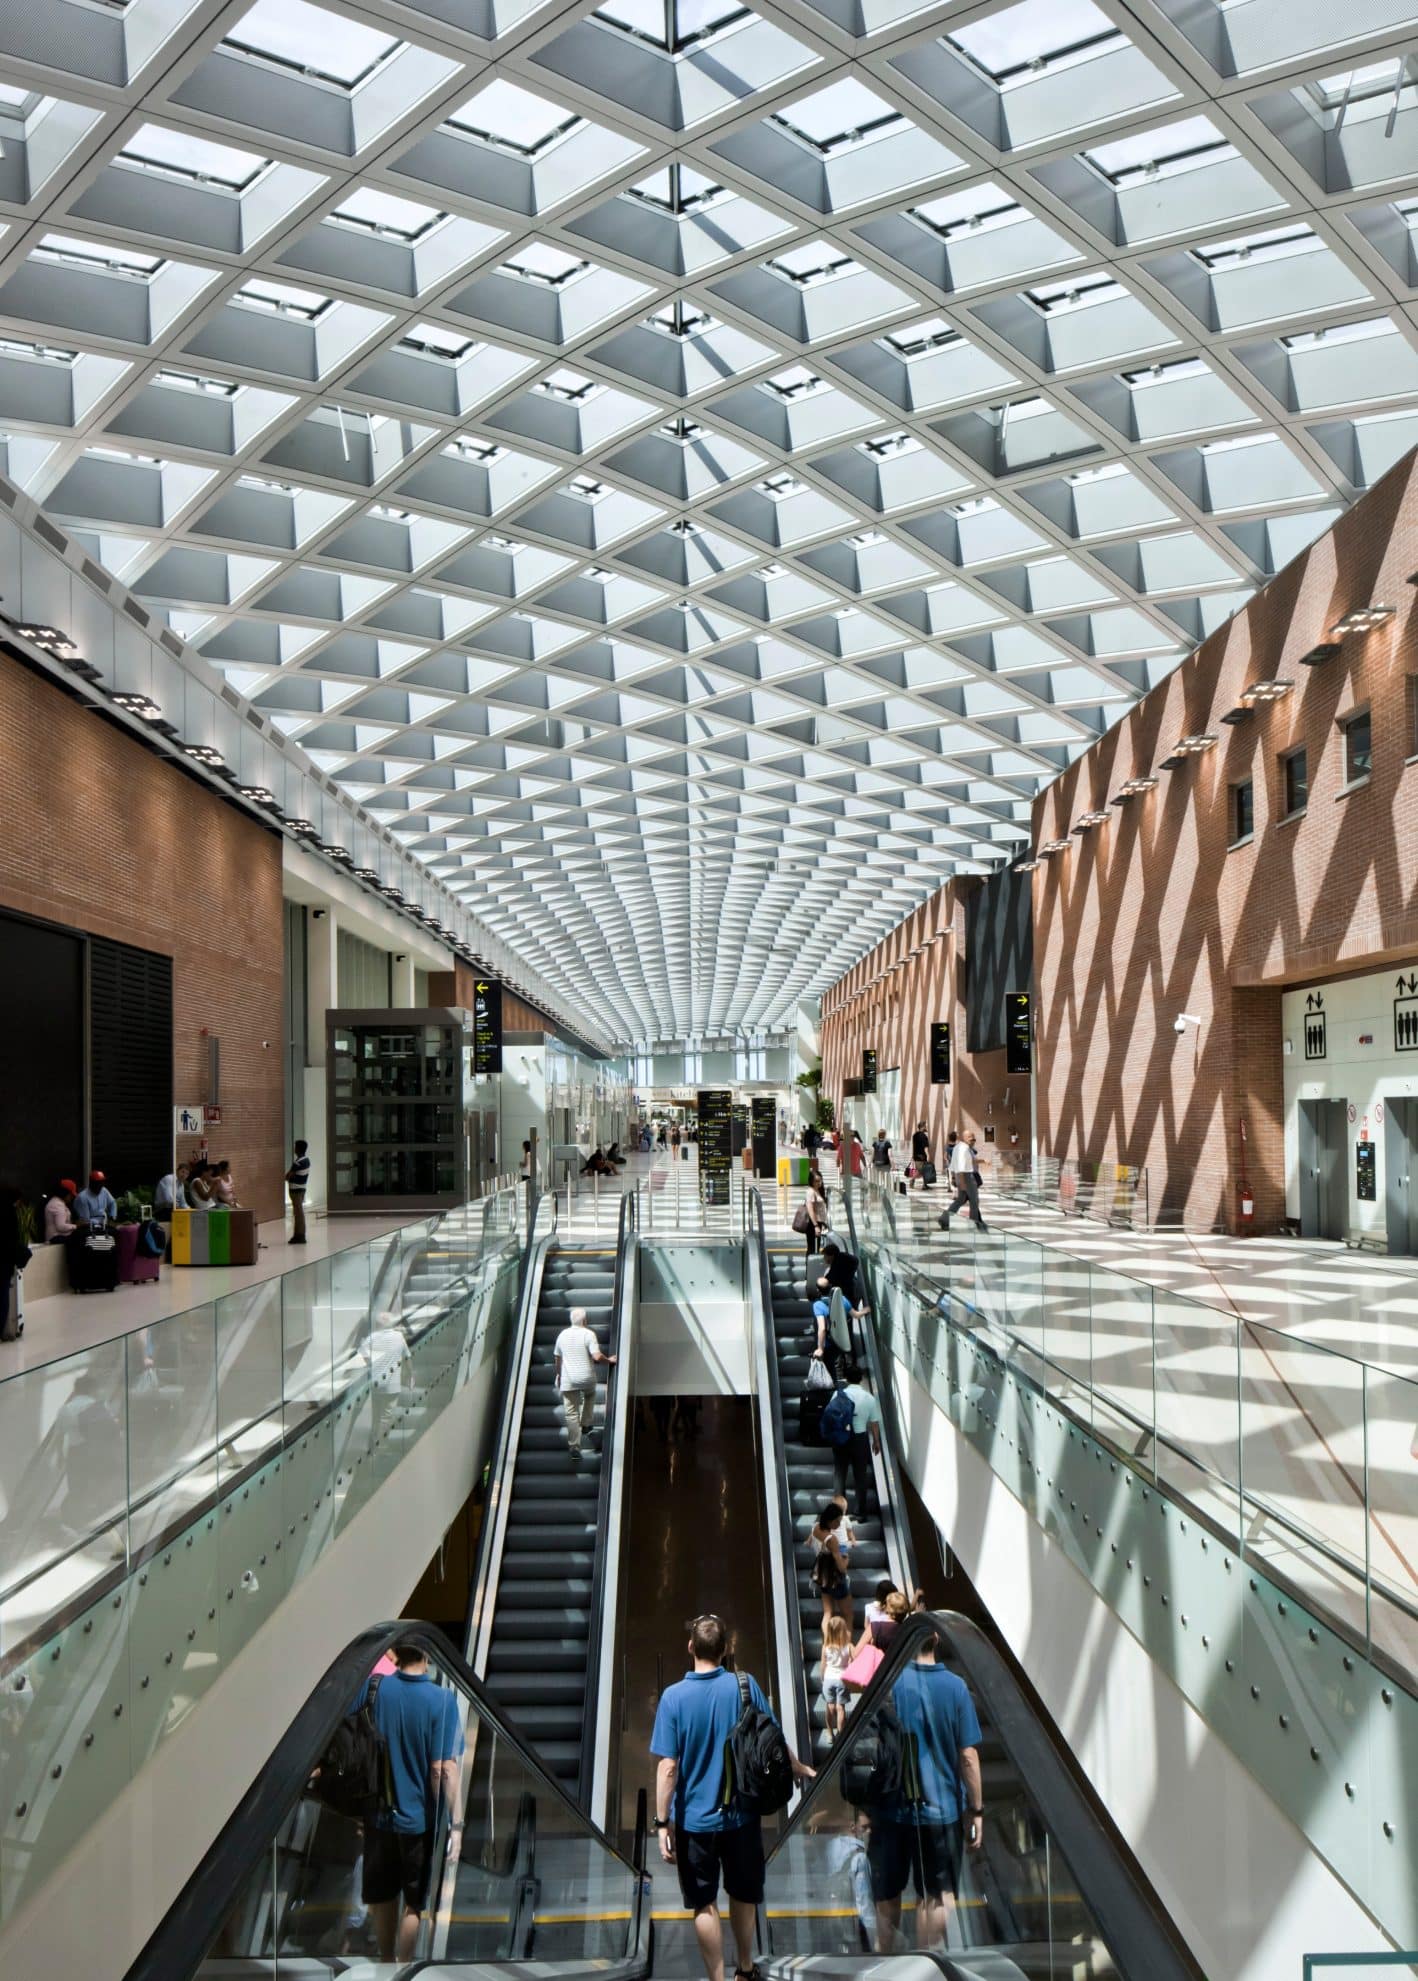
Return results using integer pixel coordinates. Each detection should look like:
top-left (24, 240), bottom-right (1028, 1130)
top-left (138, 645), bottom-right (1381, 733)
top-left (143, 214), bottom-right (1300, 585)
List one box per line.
top-left (0, 658), bottom-right (287, 1218)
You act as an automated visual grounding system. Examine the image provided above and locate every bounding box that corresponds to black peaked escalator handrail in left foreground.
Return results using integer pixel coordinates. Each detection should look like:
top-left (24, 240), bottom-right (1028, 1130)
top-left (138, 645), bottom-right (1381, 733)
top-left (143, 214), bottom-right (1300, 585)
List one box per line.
top-left (125, 1620), bottom-right (648, 1981)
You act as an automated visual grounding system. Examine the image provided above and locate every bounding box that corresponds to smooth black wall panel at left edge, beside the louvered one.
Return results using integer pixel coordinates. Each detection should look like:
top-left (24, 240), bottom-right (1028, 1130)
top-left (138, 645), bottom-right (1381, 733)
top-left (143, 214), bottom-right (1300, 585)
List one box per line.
top-left (0, 915), bottom-right (84, 1200)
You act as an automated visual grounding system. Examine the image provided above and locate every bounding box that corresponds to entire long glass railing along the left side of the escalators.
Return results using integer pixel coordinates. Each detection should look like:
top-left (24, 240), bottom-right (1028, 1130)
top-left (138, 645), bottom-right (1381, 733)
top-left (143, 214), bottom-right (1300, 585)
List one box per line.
top-left (0, 1193), bottom-right (519, 1920)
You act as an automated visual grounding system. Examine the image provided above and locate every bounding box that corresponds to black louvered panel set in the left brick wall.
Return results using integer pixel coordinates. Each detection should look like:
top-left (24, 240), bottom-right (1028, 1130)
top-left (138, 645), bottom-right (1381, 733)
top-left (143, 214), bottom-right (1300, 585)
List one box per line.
top-left (89, 935), bottom-right (172, 1189)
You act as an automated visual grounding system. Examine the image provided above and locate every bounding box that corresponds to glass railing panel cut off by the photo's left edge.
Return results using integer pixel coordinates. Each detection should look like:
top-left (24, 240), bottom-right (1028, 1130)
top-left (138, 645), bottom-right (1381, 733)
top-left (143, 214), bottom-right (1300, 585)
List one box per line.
top-left (0, 1339), bottom-right (129, 1656)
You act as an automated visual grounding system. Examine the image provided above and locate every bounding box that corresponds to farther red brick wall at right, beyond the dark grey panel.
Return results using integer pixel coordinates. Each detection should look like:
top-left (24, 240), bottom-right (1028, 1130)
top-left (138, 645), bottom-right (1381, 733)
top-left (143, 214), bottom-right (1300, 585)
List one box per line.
top-left (822, 880), bottom-right (1030, 1159)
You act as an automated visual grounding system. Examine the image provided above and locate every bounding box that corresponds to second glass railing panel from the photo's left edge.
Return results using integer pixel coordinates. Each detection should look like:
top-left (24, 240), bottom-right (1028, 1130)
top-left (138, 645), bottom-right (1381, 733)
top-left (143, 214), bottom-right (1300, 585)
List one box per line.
top-left (125, 1305), bottom-right (220, 1557)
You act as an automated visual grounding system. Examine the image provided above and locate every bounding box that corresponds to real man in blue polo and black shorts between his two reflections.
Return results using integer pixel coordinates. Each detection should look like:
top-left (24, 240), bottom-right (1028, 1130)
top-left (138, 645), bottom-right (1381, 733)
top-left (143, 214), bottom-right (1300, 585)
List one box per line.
top-left (650, 1616), bottom-right (814, 1981)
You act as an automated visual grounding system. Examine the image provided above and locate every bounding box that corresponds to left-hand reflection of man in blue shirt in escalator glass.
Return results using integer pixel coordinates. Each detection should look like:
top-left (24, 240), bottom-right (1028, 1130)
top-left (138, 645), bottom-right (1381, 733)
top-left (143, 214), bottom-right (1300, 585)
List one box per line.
top-left (355, 1644), bottom-right (463, 1963)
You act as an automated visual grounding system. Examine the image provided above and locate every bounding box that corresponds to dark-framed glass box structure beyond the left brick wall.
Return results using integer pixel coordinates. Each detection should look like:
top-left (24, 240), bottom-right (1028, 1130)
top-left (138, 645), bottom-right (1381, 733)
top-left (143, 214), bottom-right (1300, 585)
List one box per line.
top-left (327, 1006), bottom-right (467, 1212)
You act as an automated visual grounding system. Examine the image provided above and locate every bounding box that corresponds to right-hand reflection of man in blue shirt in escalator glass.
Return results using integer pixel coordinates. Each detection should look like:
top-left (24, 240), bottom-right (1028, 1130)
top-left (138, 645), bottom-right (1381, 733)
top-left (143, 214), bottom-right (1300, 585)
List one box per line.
top-left (867, 1636), bottom-right (984, 1953)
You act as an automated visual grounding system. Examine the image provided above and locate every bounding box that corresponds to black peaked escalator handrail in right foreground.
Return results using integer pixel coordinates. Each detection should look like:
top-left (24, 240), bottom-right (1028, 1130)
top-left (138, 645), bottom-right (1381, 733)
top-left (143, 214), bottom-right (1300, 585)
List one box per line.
top-left (768, 1611), bottom-right (1200, 1981)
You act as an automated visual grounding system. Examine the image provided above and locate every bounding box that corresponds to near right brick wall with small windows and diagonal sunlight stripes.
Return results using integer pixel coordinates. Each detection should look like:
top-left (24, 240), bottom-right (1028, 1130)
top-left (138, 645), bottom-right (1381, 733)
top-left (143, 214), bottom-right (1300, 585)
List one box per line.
top-left (1034, 456), bottom-right (1418, 1228)
